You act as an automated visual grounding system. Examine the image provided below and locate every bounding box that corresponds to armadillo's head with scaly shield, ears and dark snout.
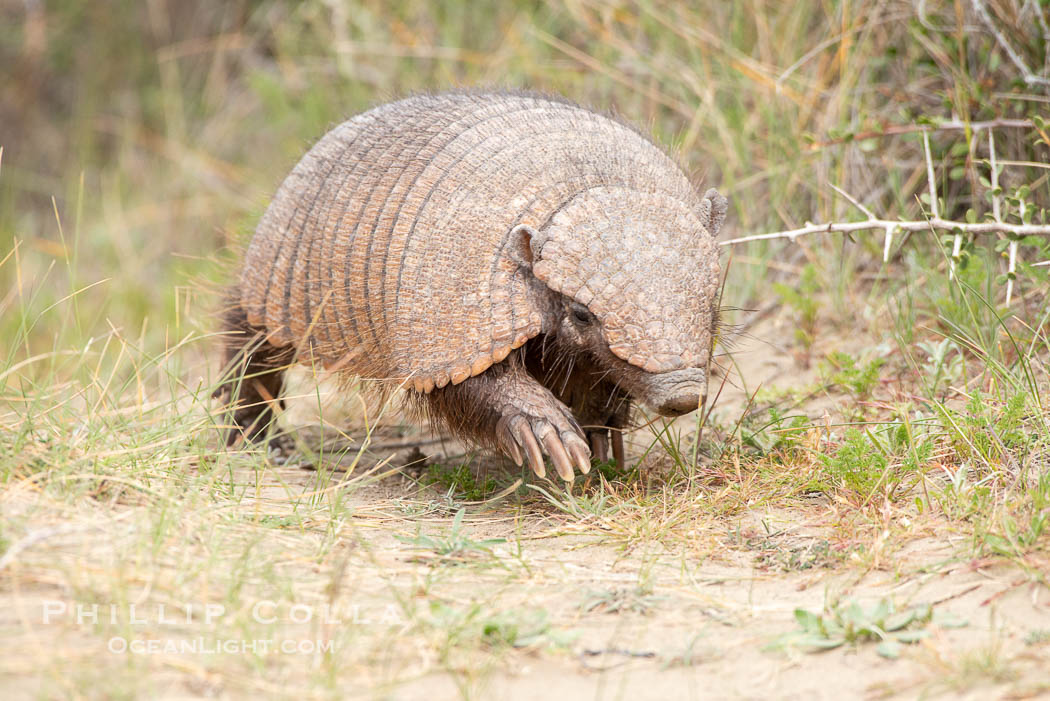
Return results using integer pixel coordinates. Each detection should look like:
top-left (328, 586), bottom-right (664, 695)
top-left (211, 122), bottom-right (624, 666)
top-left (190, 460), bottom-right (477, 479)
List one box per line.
top-left (529, 187), bottom-right (728, 416)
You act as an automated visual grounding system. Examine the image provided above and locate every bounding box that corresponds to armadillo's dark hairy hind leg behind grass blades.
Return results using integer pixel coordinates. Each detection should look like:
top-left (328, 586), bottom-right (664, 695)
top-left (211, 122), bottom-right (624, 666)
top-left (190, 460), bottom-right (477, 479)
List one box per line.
top-left (215, 290), bottom-right (291, 446)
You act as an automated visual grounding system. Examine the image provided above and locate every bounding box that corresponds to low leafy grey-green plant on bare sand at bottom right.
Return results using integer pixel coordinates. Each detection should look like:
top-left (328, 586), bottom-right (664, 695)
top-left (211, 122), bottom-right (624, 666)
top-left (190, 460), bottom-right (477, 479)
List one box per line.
top-left (770, 598), bottom-right (966, 659)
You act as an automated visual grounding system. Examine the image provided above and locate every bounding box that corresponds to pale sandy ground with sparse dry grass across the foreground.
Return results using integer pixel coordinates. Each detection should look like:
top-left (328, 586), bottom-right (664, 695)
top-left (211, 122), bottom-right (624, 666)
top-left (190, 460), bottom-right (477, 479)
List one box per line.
top-left (0, 314), bottom-right (1050, 701)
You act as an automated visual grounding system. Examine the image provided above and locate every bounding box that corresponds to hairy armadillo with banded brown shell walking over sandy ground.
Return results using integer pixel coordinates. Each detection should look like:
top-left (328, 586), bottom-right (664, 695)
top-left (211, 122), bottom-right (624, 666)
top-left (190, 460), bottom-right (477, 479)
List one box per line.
top-left (226, 92), bottom-right (727, 481)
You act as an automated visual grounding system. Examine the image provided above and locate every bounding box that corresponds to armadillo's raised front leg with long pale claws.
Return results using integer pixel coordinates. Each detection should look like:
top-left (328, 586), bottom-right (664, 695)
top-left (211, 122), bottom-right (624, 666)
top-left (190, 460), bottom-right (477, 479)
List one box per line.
top-left (422, 359), bottom-right (590, 482)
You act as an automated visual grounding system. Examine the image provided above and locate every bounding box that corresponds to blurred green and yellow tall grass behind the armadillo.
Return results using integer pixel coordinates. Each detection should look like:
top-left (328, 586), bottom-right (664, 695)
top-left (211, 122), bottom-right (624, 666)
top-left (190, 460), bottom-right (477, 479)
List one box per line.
top-left (0, 0), bottom-right (1050, 363)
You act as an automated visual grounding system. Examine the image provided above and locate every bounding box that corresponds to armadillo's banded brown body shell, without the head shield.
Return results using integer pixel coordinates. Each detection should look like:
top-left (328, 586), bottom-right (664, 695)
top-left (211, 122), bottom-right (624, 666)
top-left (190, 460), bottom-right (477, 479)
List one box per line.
top-left (240, 92), bottom-right (699, 391)
